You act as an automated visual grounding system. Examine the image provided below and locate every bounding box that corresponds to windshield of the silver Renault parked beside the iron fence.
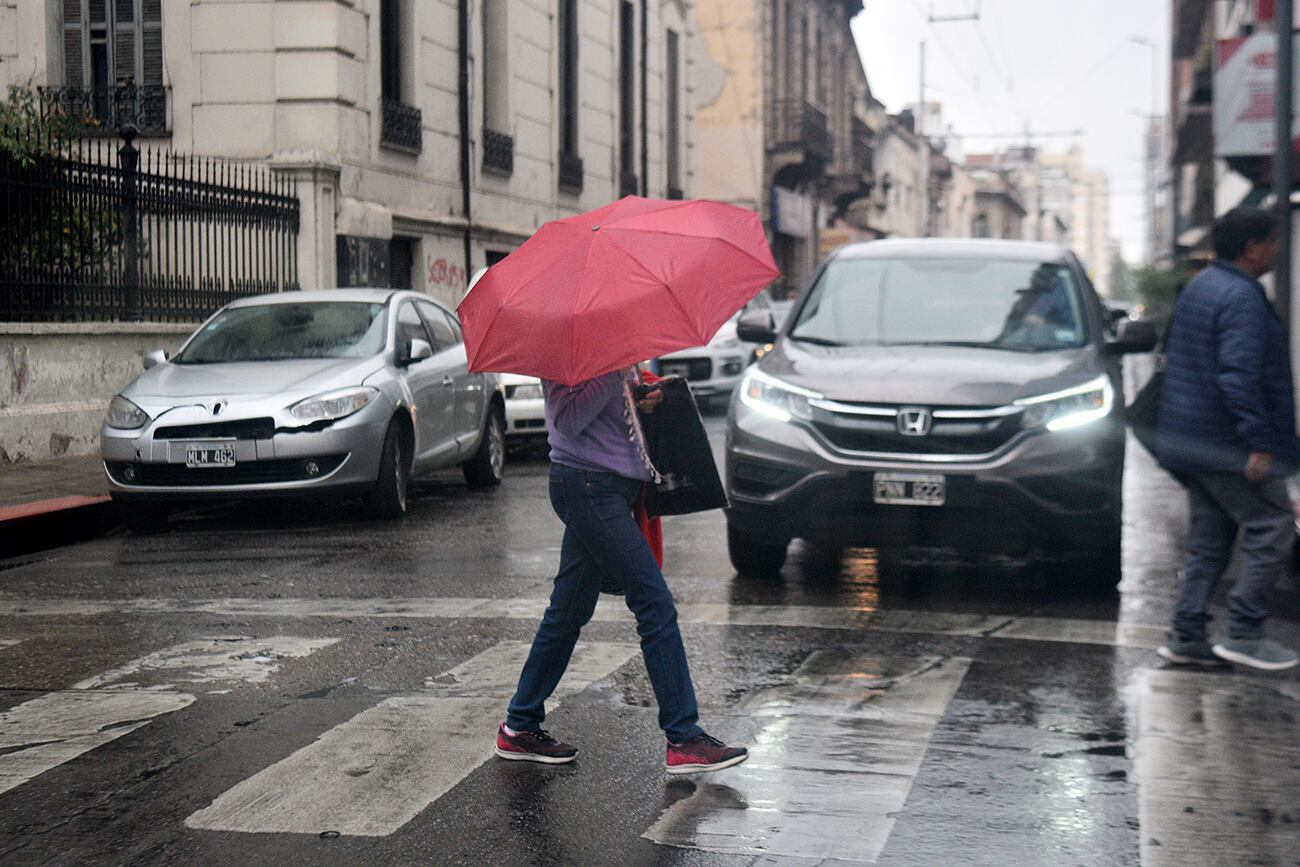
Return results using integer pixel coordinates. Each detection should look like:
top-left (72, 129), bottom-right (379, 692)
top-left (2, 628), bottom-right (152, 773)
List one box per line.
top-left (173, 302), bottom-right (385, 364)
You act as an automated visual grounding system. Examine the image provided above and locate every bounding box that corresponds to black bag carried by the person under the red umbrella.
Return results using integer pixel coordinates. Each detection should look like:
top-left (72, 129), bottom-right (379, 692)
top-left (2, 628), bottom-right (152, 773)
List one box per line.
top-left (638, 377), bottom-right (728, 517)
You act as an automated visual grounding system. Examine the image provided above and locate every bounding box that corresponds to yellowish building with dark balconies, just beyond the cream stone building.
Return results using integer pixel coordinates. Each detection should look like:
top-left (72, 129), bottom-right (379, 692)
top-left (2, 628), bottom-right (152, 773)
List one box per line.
top-left (694, 0), bottom-right (872, 295)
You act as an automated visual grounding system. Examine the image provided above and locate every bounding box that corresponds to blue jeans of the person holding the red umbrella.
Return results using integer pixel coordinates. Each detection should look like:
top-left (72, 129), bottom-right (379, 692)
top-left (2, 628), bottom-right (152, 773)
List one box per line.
top-left (506, 464), bottom-right (702, 742)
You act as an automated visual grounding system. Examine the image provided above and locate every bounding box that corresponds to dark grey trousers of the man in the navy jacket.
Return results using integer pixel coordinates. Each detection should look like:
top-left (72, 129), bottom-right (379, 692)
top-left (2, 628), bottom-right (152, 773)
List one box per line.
top-left (1173, 473), bottom-right (1296, 640)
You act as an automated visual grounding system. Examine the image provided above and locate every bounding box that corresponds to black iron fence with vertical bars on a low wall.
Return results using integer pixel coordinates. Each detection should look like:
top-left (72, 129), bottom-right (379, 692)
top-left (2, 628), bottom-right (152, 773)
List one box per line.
top-left (0, 127), bottom-right (299, 322)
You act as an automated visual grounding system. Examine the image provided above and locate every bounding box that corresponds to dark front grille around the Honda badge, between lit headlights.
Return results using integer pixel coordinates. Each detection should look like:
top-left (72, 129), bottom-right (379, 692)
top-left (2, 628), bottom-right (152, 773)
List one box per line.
top-left (813, 407), bottom-right (1021, 456)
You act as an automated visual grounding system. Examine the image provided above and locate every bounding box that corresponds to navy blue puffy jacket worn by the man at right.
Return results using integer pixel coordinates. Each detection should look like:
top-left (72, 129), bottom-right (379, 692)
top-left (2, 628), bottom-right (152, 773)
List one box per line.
top-left (1157, 261), bottom-right (1300, 474)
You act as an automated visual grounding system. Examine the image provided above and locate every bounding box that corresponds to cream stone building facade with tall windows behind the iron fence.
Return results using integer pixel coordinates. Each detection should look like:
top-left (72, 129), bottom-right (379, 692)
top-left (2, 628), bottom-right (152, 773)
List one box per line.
top-left (0, 0), bottom-right (696, 303)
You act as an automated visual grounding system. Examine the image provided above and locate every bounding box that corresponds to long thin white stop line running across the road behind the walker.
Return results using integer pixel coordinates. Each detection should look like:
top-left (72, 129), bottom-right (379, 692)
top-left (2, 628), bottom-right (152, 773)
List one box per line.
top-left (0, 597), bottom-right (1166, 649)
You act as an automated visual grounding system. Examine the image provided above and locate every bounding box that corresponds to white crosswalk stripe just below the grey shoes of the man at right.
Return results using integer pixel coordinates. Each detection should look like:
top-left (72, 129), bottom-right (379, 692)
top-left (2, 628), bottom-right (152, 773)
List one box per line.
top-left (1130, 669), bottom-right (1300, 867)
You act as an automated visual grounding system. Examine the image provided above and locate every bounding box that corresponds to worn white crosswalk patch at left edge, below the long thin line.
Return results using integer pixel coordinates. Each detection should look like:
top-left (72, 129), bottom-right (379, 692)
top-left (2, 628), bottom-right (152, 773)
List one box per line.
top-left (0, 690), bottom-right (194, 792)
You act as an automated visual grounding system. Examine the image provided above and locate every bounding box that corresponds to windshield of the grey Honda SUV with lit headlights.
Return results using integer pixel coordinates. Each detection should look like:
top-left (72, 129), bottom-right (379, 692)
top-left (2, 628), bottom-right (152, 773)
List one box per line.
top-left (789, 259), bottom-right (1084, 351)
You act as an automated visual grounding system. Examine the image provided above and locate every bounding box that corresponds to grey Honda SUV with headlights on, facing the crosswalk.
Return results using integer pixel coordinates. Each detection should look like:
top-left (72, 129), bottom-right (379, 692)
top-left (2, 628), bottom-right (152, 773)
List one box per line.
top-left (727, 239), bottom-right (1156, 588)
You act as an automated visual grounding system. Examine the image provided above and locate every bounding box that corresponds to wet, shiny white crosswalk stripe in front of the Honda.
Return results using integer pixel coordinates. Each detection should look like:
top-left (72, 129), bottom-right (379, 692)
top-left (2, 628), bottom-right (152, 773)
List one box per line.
top-left (642, 651), bottom-right (970, 862)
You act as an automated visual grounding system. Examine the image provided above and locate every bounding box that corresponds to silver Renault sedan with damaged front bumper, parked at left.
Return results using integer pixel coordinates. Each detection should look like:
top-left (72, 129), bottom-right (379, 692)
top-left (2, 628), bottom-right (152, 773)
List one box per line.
top-left (100, 289), bottom-right (506, 529)
